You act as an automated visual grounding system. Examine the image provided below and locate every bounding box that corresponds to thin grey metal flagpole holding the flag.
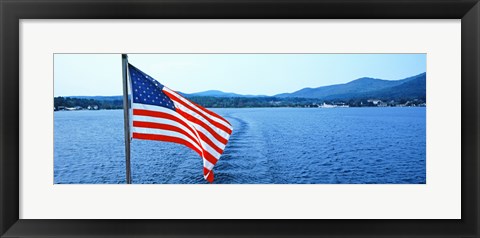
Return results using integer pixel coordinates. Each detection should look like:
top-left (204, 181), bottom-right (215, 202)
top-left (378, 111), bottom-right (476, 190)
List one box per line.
top-left (122, 54), bottom-right (132, 184)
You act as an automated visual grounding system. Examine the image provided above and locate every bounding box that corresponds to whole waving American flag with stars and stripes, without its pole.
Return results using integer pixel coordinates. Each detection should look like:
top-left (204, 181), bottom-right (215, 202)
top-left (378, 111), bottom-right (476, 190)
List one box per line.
top-left (128, 64), bottom-right (233, 182)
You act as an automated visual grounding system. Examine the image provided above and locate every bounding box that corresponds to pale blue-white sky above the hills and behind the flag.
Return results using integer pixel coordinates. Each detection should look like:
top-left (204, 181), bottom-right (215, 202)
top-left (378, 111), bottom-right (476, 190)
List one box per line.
top-left (54, 54), bottom-right (426, 97)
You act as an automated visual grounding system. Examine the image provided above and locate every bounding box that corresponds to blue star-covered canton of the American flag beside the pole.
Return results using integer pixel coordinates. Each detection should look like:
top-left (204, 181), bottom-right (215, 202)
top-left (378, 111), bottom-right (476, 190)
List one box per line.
top-left (128, 64), bottom-right (175, 110)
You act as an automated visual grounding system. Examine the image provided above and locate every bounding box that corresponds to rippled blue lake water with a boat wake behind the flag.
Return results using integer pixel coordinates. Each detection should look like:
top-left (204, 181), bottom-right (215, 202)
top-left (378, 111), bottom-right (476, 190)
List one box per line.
top-left (54, 107), bottom-right (426, 184)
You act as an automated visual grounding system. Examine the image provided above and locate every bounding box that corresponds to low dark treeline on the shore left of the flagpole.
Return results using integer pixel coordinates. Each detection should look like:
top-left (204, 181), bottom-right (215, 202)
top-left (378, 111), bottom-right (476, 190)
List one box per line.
top-left (53, 97), bottom-right (123, 109)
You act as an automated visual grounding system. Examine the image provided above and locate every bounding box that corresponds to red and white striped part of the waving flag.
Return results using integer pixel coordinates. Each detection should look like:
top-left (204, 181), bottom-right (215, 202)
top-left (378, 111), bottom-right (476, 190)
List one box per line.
top-left (132, 87), bottom-right (233, 182)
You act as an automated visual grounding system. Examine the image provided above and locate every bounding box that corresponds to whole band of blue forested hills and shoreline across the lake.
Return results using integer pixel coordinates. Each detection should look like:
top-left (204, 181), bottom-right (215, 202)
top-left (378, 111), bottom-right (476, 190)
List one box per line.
top-left (54, 73), bottom-right (426, 109)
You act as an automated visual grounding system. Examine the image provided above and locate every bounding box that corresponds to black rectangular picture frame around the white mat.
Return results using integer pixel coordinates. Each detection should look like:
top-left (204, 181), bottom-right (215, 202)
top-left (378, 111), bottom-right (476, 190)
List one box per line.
top-left (0, 0), bottom-right (480, 238)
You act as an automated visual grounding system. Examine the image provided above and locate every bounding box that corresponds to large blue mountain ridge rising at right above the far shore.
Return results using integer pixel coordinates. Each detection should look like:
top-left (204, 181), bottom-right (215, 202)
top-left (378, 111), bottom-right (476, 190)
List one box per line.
top-left (275, 73), bottom-right (426, 100)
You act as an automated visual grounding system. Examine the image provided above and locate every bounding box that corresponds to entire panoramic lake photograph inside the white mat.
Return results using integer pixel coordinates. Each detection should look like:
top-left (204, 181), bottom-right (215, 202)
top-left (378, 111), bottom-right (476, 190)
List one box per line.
top-left (53, 53), bottom-right (426, 184)
